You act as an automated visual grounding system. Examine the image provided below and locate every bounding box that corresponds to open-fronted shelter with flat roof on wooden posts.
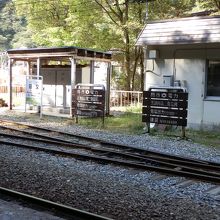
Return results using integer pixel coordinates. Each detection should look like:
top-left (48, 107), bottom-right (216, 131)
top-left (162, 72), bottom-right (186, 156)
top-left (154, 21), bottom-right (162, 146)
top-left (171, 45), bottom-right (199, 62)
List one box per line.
top-left (7, 47), bottom-right (111, 115)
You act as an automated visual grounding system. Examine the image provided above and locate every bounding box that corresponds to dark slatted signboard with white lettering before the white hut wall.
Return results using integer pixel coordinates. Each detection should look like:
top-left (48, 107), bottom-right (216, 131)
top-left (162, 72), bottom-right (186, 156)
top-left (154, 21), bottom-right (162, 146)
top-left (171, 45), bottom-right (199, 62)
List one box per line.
top-left (142, 88), bottom-right (188, 137)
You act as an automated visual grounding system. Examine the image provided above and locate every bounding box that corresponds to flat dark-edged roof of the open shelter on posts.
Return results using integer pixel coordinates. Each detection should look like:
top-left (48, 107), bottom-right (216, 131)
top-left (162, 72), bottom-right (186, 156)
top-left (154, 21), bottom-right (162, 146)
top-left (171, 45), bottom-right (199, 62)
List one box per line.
top-left (7, 46), bottom-right (112, 61)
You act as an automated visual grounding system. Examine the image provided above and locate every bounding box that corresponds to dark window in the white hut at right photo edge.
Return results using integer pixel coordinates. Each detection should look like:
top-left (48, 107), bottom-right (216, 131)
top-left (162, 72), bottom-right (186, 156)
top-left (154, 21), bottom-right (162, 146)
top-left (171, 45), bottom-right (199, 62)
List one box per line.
top-left (206, 60), bottom-right (220, 96)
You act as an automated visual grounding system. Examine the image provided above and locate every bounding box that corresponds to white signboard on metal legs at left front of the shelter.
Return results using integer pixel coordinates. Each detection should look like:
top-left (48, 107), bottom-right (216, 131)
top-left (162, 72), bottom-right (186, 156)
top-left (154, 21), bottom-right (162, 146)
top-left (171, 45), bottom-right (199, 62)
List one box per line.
top-left (25, 75), bottom-right (43, 117)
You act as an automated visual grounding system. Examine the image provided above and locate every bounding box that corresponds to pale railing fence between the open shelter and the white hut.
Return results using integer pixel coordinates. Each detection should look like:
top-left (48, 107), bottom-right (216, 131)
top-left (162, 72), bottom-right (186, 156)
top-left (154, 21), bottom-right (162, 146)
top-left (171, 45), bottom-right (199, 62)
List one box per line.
top-left (110, 90), bottom-right (143, 107)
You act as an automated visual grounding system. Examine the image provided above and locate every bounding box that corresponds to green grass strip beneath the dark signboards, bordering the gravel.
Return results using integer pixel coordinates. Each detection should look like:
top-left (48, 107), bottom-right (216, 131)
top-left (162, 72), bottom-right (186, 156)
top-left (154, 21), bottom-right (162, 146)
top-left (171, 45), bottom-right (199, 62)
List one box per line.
top-left (76, 109), bottom-right (220, 149)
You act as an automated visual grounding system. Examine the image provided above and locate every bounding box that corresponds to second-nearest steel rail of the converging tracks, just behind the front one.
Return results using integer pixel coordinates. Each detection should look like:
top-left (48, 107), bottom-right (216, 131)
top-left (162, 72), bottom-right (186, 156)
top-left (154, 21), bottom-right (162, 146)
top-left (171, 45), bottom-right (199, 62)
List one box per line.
top-left (0, 132), bottom-right (220, 172)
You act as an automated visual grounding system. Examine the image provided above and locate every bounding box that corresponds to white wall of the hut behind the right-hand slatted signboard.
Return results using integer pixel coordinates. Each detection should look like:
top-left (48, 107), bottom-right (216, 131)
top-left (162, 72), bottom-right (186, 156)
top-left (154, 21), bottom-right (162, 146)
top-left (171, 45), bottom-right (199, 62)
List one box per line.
top-left (145, 59), bottom-right (220, 128)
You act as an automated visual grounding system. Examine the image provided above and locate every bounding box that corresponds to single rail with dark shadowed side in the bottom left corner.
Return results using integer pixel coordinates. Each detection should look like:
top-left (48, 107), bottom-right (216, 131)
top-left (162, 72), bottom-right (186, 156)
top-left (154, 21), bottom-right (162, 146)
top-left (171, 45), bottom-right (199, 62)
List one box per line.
top-left (0, 187), bottom-right (111, 220)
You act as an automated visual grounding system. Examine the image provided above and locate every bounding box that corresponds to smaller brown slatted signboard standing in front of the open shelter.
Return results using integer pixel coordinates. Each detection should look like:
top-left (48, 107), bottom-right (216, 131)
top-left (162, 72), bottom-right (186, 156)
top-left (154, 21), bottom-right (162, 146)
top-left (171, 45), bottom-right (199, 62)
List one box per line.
top-left (72, 84), bottom-right (105, 125)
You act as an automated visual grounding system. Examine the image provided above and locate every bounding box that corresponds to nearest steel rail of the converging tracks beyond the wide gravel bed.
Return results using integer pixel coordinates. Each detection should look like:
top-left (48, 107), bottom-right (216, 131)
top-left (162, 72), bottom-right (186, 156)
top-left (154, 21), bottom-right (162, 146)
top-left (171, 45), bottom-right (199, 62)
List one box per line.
top-left (0, 141), bottom-right (220, 183)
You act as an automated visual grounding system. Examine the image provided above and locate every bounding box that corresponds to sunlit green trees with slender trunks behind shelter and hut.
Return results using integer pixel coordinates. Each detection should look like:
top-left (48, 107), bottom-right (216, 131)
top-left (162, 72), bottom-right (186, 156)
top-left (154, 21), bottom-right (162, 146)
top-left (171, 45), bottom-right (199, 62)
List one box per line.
top-left (13, 0), bottom-right (199, 90)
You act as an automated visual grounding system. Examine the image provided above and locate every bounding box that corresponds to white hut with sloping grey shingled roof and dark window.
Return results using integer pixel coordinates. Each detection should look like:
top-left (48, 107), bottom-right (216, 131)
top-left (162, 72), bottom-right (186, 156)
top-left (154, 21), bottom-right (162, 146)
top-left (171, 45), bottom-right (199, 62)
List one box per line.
top-left (136, 16), bottom-right (220, 128)
